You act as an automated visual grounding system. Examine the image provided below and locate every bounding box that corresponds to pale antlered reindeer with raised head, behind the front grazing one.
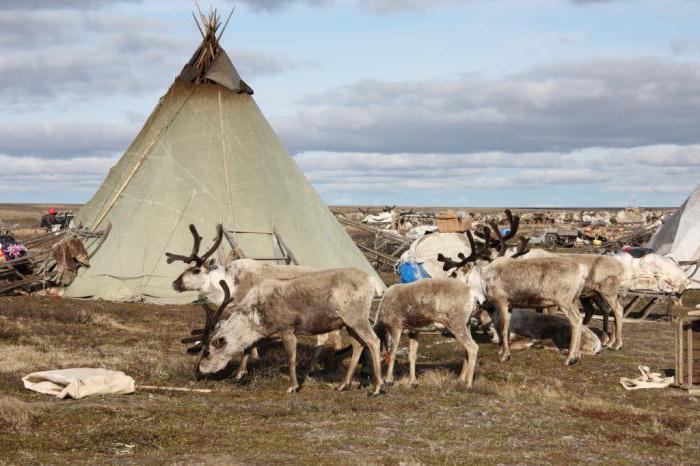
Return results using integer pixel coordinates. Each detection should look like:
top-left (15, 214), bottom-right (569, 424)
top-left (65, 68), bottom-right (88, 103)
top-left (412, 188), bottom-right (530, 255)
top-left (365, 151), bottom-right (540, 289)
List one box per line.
top-left (166, 225), bottom-right (341, 381)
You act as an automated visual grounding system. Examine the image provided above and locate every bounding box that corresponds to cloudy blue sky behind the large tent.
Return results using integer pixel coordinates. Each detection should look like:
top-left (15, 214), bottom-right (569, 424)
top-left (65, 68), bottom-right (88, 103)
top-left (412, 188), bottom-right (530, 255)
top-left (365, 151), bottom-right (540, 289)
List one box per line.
top-left (0, 0), bottom-right (700, 207)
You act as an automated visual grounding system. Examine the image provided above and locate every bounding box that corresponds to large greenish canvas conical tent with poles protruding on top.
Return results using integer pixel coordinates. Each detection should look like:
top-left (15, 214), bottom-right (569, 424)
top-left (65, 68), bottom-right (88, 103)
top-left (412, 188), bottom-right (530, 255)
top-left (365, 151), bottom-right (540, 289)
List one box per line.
top-left (66, 12), bottom-right (378, 302)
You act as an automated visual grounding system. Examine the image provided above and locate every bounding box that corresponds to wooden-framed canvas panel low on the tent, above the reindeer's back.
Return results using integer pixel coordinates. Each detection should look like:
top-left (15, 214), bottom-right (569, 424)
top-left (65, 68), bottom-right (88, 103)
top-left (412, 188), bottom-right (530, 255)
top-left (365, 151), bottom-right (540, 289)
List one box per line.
top-left (224, 228), bottom-right (299, 265)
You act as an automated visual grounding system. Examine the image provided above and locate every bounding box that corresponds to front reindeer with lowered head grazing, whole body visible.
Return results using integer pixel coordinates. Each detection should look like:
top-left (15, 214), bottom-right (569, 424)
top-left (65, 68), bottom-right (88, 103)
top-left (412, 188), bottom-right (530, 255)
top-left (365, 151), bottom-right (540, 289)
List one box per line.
top-left (185, 268), bottom-right (383, 395)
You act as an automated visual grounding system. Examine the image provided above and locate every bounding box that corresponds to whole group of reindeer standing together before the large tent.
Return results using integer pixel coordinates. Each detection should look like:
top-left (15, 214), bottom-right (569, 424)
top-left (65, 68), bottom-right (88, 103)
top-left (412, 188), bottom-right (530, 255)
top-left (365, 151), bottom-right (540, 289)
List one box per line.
top-left (166, 211), bottom-right (688, 395)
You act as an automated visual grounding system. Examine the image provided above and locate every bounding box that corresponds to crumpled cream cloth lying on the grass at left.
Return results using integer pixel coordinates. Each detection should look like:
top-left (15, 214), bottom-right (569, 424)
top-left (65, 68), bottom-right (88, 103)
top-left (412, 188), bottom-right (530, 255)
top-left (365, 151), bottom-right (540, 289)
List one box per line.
top-left (22, 367), bottom-right (135, 400)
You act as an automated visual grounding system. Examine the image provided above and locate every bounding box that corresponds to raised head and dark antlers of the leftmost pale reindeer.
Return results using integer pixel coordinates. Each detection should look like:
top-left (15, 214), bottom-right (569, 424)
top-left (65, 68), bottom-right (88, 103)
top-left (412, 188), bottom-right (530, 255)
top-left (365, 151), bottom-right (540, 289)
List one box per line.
top-left (165, 225), bottom-right (226, 296)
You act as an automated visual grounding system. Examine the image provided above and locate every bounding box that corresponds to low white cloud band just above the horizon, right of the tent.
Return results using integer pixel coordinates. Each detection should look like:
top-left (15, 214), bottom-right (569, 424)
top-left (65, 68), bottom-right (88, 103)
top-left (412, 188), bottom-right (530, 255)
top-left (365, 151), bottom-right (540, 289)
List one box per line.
top-left (295, 145), bottom-right (700, 197)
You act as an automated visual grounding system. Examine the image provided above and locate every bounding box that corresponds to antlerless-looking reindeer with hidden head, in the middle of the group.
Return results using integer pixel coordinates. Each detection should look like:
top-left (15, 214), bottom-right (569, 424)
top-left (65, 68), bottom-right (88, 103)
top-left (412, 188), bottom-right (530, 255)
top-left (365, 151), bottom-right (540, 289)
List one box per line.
top-left (375, 278), bottom-right (479, 387)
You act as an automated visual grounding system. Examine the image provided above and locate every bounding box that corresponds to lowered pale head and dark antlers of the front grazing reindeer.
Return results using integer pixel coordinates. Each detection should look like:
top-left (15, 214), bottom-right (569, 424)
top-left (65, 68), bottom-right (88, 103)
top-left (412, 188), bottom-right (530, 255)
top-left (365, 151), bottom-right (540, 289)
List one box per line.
top-left (182, 280), bottom-right (262, 374)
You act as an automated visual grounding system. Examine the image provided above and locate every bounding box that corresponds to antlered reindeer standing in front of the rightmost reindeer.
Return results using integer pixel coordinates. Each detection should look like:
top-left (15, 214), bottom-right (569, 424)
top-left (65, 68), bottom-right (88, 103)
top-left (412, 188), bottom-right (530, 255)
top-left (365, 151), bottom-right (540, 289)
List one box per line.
top-left (438, 227), bottom-right (587, 365)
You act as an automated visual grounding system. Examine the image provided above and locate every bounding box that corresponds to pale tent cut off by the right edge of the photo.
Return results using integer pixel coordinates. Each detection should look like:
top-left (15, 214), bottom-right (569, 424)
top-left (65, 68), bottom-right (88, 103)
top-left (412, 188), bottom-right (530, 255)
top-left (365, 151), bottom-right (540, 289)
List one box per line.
top-left (648, 186), bottom-right (700, 288)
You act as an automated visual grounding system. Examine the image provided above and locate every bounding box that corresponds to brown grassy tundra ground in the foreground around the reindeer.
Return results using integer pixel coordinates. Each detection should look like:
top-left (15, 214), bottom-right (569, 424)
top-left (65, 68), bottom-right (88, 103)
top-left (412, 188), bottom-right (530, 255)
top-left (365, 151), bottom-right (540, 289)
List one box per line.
top-left (0, 297), bottom-right (700, 464)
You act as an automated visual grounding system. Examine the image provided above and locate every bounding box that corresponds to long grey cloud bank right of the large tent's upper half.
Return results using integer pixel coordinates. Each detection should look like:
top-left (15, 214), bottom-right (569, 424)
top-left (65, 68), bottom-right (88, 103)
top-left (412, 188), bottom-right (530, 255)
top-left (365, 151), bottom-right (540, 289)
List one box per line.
top-left (278, 58), bottom-right (700, 153)
